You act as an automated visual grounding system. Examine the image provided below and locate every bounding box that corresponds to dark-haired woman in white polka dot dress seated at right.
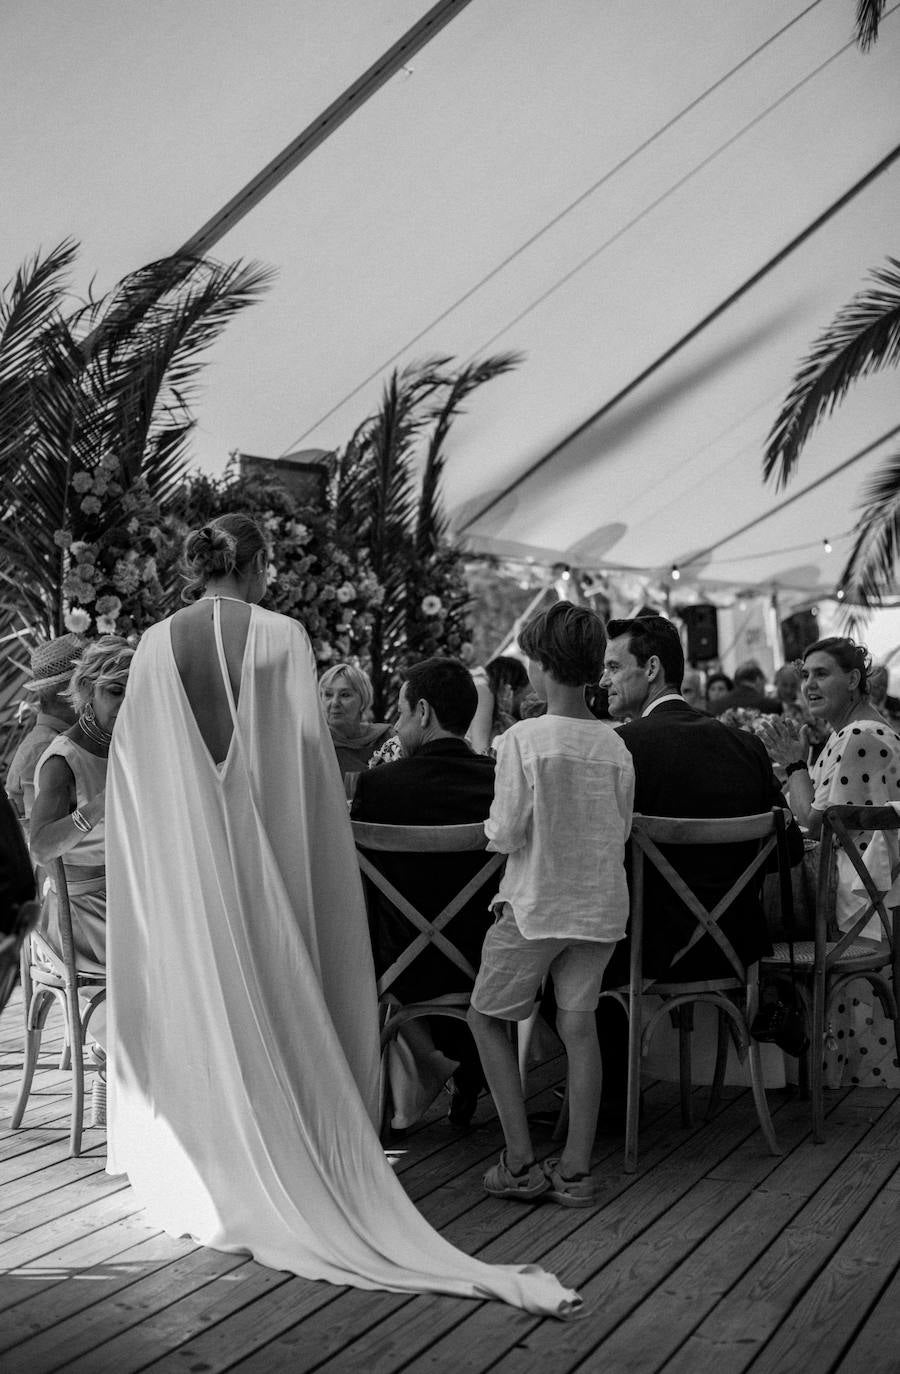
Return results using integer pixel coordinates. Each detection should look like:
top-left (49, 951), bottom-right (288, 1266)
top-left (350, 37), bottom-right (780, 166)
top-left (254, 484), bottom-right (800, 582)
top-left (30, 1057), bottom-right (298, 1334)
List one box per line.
top-left (760, 636), bottom-right (900, 1087)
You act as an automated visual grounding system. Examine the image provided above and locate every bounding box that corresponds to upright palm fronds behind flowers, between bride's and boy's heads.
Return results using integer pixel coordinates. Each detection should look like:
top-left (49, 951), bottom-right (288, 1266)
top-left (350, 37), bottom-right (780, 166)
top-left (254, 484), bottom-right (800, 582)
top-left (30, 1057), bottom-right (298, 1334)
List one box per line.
top-left (333, 353), bottom-right (519, 719)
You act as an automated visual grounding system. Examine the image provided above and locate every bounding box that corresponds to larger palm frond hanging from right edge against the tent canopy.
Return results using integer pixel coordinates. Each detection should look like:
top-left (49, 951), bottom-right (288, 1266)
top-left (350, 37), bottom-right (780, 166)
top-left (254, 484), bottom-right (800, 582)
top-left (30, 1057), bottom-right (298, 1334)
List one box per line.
top-left (763, 258), bottom-right (900, 486)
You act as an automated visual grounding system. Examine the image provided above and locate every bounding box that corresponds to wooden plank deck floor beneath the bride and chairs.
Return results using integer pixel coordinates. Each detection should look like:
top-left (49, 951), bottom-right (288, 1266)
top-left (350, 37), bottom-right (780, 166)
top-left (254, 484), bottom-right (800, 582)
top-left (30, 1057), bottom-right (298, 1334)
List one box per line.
top-left (0, 1004), bottom-right (900, 1374)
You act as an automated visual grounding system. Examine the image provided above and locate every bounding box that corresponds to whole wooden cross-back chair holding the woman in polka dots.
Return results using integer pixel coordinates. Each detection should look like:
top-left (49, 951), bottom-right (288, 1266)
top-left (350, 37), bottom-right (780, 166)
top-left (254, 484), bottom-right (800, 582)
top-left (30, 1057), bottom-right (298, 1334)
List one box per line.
top-left (761, 807), bottom-right (900, 1143)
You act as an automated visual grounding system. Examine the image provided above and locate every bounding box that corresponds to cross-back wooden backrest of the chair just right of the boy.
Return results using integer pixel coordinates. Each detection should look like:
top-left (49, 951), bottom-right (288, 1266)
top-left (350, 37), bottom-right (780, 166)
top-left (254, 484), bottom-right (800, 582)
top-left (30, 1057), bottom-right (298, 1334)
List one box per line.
top-left (631, 808), bottom-right (786, 981)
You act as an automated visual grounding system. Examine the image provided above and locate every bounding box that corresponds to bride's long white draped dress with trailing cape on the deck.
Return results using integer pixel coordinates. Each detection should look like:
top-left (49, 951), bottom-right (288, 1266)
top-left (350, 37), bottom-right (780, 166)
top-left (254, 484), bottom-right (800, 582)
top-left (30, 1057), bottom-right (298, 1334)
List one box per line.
top-left (107, 603), bottom-right (578, 1315)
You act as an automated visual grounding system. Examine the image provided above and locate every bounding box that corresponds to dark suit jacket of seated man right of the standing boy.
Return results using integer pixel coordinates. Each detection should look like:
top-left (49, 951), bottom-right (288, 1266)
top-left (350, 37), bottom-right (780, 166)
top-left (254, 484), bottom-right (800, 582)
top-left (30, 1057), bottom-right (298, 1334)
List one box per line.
top-left (606, 701), bottom-right (802, 985)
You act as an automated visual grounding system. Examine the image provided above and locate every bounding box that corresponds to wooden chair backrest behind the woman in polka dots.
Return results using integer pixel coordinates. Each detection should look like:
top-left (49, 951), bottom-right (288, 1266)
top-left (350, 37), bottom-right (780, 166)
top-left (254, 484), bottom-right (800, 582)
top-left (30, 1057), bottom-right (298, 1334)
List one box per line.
top-left (816, 807), bottom-right (900, 963)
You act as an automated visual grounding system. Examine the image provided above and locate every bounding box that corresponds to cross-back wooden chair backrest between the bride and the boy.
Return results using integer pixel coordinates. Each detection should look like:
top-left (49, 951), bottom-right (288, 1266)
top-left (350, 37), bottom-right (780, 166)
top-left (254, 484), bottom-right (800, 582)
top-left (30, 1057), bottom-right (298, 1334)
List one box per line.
top-left (352, 820), bottom-right (506, 996)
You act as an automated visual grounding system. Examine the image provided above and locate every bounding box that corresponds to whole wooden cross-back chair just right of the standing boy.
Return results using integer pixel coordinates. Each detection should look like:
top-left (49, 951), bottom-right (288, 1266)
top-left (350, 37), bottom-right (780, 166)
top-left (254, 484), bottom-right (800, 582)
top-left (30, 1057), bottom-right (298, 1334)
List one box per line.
top-left (621, 809), bottom-right (786, 1173)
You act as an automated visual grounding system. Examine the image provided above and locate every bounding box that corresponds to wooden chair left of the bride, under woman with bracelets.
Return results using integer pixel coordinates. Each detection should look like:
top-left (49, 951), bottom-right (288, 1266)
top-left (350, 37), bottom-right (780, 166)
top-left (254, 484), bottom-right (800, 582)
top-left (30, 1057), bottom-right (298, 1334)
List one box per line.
top-left (10, 859), bottom-right (106, 1157)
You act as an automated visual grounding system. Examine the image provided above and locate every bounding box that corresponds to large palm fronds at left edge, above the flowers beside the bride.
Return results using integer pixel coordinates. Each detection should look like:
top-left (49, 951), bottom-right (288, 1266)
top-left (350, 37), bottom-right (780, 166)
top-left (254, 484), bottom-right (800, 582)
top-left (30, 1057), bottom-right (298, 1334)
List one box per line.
top-left (0, 240), bottom-right (271, 763)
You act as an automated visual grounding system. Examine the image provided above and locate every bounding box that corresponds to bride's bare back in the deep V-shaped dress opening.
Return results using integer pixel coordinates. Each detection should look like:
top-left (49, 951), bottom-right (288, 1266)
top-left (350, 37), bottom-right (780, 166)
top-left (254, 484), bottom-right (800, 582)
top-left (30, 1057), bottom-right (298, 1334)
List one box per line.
top-left (170, 598), bottom-right (251, 764)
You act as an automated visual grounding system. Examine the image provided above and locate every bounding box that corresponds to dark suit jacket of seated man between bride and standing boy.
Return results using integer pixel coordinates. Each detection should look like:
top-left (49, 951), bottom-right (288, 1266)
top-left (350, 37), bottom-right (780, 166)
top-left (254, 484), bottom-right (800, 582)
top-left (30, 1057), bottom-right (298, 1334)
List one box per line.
top-left (350, 738), bottom-right (500, 1002)
